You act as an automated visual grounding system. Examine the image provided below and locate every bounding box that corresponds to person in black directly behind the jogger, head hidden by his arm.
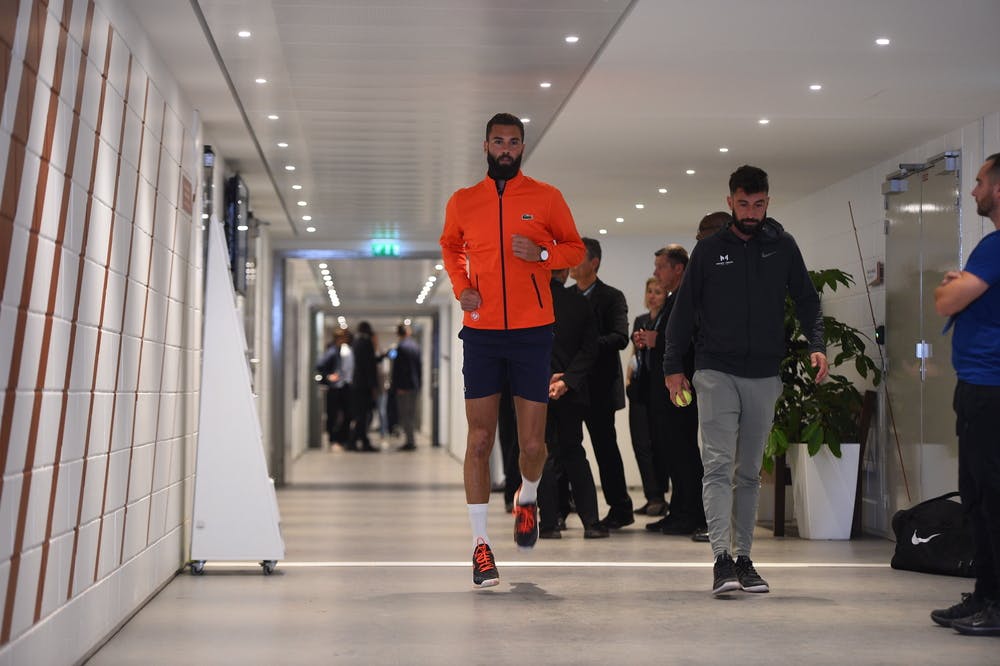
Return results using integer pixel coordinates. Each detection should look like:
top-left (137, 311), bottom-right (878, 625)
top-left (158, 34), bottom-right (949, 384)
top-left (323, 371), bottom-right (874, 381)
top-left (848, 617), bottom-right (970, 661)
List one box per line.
top-left (538, 269), bottom-right (608, 539)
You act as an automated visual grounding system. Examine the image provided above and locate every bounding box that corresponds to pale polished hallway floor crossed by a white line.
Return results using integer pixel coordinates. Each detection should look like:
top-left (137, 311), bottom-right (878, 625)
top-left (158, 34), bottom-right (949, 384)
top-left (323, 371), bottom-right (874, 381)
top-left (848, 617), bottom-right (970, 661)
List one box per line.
top-left (90, 438), bottom-right (1000, 666)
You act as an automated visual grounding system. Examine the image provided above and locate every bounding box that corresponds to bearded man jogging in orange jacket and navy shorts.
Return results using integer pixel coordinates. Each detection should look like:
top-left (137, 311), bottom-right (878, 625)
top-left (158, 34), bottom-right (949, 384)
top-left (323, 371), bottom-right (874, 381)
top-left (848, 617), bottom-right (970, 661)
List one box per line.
top-left (441, 113), bottom-right (584, 587)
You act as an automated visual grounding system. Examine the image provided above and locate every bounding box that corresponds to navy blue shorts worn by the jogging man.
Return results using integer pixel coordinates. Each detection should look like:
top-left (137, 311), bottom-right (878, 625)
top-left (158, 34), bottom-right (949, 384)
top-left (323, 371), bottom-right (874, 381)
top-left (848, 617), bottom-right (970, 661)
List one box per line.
top-left (458, 325), bottom-right (554, 402)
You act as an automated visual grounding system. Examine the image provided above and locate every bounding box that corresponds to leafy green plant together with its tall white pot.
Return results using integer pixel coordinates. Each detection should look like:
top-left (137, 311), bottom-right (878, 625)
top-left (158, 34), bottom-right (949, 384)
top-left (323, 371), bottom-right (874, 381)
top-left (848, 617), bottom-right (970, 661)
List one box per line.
top-left (764, 268), bottom-right (882, 539)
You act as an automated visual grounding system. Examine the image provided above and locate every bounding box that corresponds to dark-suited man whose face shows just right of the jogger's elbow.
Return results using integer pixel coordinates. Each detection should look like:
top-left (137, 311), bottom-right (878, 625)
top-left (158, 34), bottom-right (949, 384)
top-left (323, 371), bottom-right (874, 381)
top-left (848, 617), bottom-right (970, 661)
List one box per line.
top-left (569, 238), bottom-right (635, 529)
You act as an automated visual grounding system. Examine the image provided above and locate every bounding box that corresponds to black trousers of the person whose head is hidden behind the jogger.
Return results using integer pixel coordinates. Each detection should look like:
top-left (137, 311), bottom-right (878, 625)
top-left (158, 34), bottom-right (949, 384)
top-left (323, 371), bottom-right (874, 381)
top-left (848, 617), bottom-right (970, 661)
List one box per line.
top-left (538, 396), bottom-right (600, 530)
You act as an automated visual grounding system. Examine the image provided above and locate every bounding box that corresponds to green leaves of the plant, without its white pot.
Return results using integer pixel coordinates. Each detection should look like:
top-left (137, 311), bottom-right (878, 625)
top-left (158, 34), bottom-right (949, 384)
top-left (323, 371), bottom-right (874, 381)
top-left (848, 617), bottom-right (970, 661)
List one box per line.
top-left (764, 268), bottom-right (882, 472)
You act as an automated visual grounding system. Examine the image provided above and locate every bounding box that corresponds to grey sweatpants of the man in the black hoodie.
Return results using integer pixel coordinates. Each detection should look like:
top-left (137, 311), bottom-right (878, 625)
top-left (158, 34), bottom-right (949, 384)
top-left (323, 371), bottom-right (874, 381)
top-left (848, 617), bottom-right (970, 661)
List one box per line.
top-left (693, 370), bottom-right (782, 557)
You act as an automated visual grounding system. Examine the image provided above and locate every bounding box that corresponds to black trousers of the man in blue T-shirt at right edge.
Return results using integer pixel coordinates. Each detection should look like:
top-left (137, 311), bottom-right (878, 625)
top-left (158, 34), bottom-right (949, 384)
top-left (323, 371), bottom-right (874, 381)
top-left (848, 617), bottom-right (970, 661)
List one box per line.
top-left (954, 381), bottom-right (1000, 601)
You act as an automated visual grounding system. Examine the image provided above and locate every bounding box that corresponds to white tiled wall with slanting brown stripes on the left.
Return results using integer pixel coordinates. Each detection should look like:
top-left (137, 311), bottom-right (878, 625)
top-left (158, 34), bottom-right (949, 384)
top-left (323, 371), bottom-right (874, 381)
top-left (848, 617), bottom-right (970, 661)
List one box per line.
top-left (0, 0), bottom-right (202, 664)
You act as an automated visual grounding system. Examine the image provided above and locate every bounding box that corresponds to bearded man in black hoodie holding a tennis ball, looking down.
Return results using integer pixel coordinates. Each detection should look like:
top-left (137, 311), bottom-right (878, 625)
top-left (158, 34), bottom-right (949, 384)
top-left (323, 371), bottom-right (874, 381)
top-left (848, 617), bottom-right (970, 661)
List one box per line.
top-left (663, 165), bottom-right (827, 594)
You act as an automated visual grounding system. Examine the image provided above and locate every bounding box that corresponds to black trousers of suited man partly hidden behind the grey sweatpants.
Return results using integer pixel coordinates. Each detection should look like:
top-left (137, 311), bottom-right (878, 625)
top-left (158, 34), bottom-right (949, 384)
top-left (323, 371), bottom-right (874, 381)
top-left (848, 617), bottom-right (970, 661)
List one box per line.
top-left (648, 382), bottom-right (705, 527)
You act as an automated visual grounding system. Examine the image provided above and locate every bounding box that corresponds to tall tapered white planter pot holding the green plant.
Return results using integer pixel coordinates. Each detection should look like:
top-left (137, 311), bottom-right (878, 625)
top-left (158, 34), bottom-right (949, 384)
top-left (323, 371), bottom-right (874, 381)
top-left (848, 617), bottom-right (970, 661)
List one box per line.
top-left (788, 444), bottom-right (861, 539)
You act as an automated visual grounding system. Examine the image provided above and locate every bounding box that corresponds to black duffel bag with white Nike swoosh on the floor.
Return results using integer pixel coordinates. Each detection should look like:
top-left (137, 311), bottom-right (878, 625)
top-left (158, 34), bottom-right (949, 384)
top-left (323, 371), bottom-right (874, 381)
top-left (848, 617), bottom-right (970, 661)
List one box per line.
top-left (892, 492), bottom-right (976, 578)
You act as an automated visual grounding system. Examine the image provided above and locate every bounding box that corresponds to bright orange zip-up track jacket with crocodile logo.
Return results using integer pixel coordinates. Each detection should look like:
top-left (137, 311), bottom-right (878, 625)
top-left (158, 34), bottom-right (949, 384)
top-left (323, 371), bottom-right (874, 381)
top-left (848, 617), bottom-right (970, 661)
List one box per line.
top-left (441, 172), bottom-right (586, 330)
